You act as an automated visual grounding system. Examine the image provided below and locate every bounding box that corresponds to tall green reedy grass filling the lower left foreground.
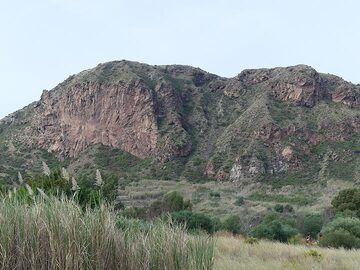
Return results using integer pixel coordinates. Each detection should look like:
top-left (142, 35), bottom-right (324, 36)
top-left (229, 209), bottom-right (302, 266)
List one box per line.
top-left (0, 197), bottom-right (214, 270)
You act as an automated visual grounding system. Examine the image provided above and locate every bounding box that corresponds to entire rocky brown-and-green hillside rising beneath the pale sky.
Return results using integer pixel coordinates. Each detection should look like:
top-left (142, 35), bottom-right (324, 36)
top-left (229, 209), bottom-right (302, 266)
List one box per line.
top-left (0, 61), bottom-right (360, 185)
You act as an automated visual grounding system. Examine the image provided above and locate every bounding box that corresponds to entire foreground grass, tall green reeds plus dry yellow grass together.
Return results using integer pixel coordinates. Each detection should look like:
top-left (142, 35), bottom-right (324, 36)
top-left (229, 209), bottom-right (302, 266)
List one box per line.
top-left (0, 193), bottom-right (360, 270)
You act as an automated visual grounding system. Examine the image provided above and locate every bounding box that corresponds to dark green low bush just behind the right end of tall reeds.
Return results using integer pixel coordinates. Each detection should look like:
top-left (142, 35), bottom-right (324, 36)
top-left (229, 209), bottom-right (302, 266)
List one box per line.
top-left (171, 210), bottom-right (214, 234)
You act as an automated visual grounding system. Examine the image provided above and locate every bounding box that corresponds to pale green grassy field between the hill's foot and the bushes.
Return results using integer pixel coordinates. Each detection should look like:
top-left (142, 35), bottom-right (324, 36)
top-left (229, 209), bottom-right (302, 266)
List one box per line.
top-left (120, 180), bottom-right (353, 221)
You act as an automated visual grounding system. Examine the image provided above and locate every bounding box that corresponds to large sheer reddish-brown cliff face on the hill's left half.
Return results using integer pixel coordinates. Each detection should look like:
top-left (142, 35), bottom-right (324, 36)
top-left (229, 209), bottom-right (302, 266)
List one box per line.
top-left (29, 81), bottom-right (158, 158)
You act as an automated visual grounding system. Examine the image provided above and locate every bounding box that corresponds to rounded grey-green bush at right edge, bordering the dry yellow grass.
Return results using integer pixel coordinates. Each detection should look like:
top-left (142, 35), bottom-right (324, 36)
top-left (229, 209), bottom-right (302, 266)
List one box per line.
top-left (320, 217), bottom-right (360, 249)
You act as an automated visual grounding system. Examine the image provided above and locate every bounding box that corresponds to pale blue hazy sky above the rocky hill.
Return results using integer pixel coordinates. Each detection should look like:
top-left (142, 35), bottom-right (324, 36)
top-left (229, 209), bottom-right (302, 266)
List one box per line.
top-left (0, 0), bottom-right (360, 118)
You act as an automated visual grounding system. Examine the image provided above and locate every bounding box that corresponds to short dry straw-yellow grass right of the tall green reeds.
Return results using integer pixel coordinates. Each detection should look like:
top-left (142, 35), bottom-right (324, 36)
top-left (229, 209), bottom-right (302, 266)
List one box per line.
top-left (214, 237), bottom-right (360, 270)
